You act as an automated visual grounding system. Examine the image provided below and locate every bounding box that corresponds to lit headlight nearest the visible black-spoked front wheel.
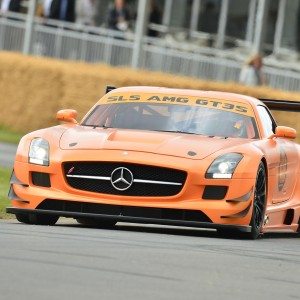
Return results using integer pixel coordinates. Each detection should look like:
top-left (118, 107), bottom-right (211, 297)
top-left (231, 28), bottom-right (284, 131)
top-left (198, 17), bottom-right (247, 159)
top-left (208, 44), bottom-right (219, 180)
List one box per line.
top-left (205, 153), bottom-right (243, 178)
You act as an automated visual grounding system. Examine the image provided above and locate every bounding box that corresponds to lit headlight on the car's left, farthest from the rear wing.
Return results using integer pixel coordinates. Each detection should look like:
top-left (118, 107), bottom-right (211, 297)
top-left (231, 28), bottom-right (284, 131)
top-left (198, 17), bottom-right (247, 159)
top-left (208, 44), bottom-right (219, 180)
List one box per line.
top-left (29, 138), bottom-right (49, 166)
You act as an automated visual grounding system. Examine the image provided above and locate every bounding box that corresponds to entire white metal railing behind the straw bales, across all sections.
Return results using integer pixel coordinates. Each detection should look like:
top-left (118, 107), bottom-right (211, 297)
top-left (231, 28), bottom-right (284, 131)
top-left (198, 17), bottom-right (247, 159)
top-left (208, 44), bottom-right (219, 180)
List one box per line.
top-left (0, 13), bottom-right (300, 91)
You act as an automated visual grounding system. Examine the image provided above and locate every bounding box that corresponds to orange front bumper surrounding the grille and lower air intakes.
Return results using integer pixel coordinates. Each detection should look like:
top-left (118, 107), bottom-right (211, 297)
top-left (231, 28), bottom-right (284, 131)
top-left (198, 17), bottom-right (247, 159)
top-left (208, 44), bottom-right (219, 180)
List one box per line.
top-left (8, 150), bottom-right (255, 228)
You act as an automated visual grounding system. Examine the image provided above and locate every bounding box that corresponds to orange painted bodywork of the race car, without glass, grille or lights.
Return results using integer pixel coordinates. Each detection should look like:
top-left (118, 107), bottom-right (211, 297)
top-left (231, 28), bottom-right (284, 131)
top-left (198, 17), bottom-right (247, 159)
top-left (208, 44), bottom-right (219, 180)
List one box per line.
top-left (7, 87), bottom-right (300, 231)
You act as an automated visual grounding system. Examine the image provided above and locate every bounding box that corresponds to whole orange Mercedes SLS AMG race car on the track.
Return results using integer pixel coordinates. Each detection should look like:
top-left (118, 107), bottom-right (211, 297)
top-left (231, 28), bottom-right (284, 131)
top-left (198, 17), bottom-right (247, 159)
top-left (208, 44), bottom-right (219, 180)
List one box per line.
top-left (7, 87), bottom-right (300, 239)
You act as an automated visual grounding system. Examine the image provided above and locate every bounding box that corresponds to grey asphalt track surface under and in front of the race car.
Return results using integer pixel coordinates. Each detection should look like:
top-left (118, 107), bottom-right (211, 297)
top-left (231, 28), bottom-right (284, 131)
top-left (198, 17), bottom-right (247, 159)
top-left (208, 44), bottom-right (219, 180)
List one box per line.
top-left (0, 142), bottom-right (300, 300)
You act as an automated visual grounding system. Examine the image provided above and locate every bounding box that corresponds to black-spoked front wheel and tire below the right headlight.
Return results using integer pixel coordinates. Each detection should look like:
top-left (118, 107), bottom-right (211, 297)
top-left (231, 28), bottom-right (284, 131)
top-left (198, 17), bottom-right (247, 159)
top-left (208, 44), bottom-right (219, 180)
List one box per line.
top-left (218, 162), bottom-right (267, 240)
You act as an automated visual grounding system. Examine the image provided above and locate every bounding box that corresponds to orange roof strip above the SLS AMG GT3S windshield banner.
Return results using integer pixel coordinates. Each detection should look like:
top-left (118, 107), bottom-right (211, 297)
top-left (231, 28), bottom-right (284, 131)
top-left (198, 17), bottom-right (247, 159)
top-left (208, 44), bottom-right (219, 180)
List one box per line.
top-left (109, 86), bottom-right (265, 106)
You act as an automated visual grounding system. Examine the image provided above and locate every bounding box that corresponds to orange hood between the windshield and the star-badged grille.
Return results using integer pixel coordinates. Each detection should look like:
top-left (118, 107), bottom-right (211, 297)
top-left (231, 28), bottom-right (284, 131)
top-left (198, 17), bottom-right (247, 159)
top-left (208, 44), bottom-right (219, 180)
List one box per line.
top-left (60, 126), bottom-right (249, 159)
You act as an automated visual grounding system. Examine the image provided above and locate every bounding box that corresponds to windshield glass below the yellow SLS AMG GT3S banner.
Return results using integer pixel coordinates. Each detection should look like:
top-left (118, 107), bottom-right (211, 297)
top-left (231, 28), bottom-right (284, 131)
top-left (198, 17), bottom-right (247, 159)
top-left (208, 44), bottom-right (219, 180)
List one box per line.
top-left (82, 103), bottom-right (257, 139)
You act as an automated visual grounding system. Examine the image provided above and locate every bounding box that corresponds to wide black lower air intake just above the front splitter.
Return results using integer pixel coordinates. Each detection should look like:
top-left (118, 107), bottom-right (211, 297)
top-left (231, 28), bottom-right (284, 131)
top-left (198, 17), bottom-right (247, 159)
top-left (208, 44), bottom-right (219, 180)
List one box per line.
top-left (37, 199), bottom-right (212, 223)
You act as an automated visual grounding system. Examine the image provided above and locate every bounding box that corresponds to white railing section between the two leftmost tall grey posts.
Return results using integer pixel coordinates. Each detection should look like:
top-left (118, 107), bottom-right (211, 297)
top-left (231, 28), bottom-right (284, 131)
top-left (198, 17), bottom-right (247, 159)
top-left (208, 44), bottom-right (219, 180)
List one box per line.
top-left (30, 24), bottom-right (132, 65)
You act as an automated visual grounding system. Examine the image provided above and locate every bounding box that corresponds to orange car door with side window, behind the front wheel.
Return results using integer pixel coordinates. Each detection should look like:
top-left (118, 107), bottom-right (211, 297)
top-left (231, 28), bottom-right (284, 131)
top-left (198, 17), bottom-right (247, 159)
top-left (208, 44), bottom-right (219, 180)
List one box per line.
top-left (257, 105), bottom-right (298, 204)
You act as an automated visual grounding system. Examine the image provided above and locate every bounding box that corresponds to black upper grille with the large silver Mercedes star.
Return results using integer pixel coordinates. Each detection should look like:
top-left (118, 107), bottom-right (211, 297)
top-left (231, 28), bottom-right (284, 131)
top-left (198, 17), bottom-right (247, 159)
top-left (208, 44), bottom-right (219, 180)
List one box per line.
top-left (63, 162), bottom-right (187, 197)
